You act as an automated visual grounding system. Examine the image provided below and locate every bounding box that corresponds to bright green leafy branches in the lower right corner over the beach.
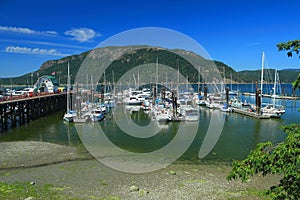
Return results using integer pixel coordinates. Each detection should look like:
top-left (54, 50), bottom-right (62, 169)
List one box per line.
top-left (227, 124), bottom-right (300, 199)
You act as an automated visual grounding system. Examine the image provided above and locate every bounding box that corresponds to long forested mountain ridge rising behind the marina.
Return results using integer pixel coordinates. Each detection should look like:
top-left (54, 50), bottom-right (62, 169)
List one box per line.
top-left (0, 46), bottom-right (300, 85)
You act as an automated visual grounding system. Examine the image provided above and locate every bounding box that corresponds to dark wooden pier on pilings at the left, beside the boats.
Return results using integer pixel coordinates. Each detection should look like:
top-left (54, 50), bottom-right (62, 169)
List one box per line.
top-left (0, 93), bottom-right (67, 132)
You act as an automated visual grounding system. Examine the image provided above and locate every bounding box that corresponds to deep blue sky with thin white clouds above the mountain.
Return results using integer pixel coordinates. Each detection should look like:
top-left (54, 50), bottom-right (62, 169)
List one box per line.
top-left (0, 0), bottom-right (300, 77)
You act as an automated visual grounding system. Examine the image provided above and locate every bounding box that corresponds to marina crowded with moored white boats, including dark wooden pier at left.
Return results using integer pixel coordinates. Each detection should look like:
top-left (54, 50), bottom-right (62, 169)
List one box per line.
top-left (0, 80), bottom-right (299, 132)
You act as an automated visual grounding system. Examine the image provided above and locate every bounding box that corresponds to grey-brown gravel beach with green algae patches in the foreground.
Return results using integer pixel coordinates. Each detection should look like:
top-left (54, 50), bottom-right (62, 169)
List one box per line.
top-left (0, 142), bottom-right (280, 200)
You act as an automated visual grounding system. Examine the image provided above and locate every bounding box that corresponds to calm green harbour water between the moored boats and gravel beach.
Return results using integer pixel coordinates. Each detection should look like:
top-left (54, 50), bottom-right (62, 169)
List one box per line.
top-left (0, 93), bottom-right (300, 161)
